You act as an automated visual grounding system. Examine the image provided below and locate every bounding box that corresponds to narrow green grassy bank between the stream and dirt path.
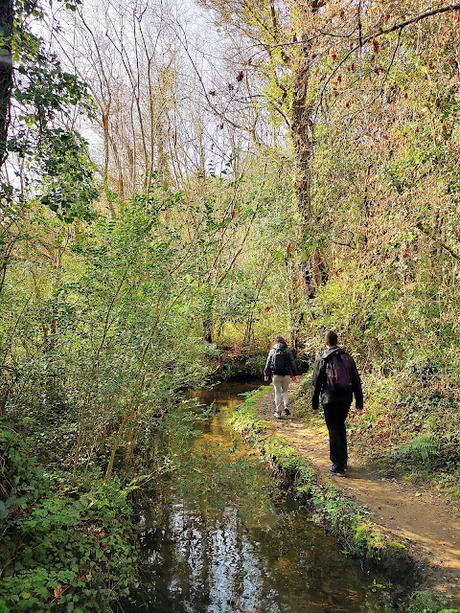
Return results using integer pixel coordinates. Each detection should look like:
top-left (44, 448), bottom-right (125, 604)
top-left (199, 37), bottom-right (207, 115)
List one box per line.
top-left (232, 388), bottom-right (454, 612)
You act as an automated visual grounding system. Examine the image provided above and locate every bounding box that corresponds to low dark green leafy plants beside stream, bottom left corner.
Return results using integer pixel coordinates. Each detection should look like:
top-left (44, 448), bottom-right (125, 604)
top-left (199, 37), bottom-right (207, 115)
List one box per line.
top-left (0, 429), bottom-right (136, 611)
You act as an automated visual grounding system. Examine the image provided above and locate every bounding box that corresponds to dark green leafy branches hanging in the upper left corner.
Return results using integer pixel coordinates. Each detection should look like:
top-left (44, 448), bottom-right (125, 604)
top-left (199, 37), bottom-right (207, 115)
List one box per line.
top-left (0, 0), bottom-right (97, 220)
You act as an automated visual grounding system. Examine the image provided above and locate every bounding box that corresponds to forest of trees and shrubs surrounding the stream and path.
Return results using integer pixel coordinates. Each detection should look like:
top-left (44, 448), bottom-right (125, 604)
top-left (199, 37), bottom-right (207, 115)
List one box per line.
top-left (0, 0), bottom-right (460, 610)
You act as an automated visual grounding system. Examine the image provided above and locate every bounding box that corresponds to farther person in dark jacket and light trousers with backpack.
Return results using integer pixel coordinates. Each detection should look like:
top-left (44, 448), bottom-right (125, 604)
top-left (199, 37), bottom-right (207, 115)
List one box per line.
top-left (264, 336), bottom-right (296, 419)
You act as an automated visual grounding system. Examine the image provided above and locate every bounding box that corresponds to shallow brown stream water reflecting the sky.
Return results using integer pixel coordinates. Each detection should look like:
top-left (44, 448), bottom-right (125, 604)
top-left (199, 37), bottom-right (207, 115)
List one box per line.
top-left (123, 382), bottom-right (384, 613)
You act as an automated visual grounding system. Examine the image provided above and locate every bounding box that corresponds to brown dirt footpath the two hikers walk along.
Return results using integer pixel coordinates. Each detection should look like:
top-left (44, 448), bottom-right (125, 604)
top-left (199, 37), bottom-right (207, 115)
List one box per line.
top-left (260, 384), bottom-right (460, 602)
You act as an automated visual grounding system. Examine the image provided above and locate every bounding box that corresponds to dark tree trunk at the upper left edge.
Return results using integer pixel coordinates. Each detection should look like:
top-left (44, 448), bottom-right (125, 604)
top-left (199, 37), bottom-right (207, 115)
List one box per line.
top-left (0, 0), bottom-right (14, 167)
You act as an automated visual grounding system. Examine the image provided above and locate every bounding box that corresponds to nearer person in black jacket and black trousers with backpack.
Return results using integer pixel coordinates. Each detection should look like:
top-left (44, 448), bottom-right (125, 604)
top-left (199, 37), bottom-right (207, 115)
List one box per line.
top-left (312, 331), bottom-right (363, 477)
